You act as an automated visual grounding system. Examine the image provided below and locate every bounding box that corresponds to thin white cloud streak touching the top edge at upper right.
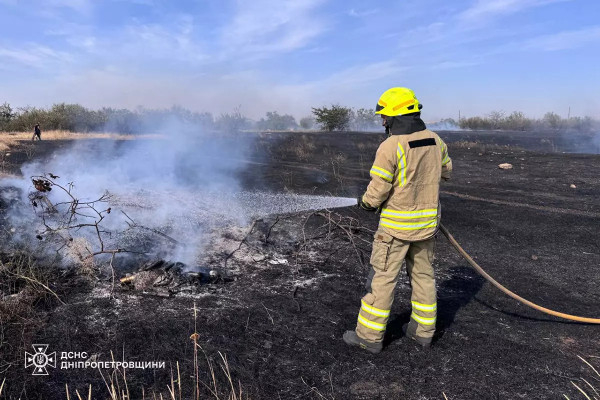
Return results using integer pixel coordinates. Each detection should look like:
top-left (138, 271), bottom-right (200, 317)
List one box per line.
top-left (458, 0), bottom-right (571, 22)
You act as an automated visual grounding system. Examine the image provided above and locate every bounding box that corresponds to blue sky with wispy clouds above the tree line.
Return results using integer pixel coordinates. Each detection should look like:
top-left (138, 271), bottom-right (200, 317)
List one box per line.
top-left (0, 0), bottom-right (600, 121)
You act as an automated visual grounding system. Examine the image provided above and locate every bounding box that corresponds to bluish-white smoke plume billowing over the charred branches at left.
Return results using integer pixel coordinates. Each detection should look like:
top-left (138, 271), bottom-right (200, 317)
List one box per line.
top-left (2, 120), bottom-right (251, 263)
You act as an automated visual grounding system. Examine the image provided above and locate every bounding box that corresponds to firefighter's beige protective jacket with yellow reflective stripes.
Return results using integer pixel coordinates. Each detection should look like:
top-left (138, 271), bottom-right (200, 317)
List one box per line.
top-left (363, 129), bottom-right (452, 241)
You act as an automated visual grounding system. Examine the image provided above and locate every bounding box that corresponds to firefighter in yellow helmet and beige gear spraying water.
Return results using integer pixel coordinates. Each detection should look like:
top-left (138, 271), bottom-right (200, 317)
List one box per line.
top-left (343, 87), bottom-right (452, 353)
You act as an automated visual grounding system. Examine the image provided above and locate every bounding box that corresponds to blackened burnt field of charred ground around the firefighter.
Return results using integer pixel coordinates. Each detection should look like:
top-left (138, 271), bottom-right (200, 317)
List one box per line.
top-left (0, 132), bottom-right (600, 399)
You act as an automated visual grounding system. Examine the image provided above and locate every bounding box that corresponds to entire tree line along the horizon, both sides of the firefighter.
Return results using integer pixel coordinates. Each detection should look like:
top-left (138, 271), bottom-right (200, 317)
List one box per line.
top-left (0, 103), bottom-right (600, 134)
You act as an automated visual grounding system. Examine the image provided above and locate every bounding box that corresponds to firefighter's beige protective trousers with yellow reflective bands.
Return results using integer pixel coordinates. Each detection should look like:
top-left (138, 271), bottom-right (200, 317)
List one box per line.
top-left (356, 228), bottom-right (437, 342)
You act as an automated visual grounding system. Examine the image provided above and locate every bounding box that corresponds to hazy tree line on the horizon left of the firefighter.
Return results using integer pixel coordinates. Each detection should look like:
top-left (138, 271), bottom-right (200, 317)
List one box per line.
top-left (0, 103), bottom-right (380, 134)
